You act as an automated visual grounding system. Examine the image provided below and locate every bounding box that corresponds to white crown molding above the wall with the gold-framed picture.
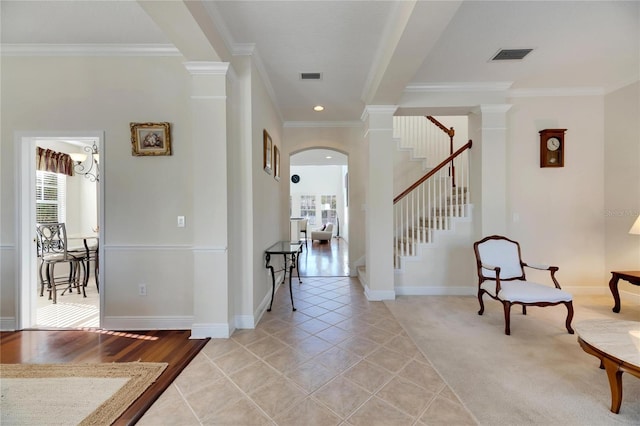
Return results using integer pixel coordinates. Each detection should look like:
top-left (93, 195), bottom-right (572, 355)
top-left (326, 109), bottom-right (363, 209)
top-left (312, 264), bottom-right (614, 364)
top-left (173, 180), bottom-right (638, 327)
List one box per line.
top-left (0, 43), bottom-right (182, 56)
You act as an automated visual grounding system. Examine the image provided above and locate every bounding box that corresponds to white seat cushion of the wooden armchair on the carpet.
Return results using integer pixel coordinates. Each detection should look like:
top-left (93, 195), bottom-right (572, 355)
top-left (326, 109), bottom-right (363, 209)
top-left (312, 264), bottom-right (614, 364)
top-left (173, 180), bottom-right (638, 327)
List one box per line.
top-left (480, 280), bottom-right (573, 303)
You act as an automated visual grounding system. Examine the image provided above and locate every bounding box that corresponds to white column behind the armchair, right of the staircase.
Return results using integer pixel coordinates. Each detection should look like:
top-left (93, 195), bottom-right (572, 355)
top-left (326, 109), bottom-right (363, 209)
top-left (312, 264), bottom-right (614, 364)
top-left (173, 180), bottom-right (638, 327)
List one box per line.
top-left (469, 104), bottom-right (511, 237)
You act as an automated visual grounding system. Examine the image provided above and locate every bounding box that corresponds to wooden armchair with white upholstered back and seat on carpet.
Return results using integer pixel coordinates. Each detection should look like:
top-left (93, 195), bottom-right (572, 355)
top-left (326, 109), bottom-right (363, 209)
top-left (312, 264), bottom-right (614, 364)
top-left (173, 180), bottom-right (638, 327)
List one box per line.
top-left (473, 235), bottom-right (573, 335)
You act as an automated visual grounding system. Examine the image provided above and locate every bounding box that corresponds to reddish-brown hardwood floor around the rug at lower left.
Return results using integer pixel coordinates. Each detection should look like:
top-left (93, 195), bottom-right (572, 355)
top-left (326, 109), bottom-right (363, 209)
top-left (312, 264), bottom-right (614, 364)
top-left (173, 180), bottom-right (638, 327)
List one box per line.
top-left (0, 329), bottom-right (209, 425)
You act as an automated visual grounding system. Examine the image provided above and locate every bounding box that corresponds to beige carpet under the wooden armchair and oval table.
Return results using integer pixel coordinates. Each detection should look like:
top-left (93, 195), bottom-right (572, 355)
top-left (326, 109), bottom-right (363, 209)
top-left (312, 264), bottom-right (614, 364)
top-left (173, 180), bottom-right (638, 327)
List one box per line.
top-left (385, 296), bottom-right (640, 426)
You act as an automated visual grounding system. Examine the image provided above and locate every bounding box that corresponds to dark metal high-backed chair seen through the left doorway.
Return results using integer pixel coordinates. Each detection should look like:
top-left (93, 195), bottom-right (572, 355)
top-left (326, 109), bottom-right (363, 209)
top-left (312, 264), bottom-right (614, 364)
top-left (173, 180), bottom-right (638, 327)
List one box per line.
top-left (36, 223), bottom-right (88, 304)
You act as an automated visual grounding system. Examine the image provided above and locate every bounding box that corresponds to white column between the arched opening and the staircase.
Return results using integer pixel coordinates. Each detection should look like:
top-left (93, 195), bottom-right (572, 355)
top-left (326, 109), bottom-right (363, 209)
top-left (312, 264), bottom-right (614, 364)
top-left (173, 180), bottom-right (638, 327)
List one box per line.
top-left (362, 105), bottom-right (397, 300)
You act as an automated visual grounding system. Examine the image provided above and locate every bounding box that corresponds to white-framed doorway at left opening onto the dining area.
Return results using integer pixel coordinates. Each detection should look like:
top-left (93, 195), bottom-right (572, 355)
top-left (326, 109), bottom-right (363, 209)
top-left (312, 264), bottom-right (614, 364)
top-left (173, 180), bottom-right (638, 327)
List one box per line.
top-left (15, 131), bottom-right (104, 329)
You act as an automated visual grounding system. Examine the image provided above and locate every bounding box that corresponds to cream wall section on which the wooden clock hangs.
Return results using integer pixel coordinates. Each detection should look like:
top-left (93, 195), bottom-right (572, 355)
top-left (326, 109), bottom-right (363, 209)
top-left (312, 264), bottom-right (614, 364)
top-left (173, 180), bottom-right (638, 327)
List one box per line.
top-left (506, 96), bottom-right (607, 288)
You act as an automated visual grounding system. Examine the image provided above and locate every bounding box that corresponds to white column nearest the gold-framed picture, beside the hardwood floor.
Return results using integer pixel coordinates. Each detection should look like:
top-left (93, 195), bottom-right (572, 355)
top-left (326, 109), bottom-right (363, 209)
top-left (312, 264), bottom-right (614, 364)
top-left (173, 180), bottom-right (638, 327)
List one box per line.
top-left (185, 62), bottom-right (232, 338)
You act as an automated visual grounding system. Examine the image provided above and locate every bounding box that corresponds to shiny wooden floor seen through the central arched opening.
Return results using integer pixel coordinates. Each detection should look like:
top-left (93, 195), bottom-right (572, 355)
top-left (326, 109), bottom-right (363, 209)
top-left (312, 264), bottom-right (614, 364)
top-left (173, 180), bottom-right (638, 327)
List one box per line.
top-left (294, 238), bottom-right (349, 277)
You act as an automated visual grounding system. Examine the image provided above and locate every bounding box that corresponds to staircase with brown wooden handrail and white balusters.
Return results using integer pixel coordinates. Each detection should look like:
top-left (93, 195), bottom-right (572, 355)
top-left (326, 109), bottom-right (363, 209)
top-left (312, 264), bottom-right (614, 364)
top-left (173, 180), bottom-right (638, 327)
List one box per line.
top-left (393, 117), bottom-right (472, 294)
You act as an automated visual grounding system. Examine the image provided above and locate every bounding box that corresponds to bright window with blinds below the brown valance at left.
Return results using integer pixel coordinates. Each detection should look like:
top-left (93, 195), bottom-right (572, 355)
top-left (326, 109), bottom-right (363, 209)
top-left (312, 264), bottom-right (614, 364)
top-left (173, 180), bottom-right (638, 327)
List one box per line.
top-left (36, 170), bottom-right (67, 223)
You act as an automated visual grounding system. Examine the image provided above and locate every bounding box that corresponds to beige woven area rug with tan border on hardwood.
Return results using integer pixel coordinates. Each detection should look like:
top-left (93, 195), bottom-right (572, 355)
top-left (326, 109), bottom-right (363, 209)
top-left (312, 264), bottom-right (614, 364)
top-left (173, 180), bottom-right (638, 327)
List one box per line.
top-left (0, 362), bottom-right (168, 426)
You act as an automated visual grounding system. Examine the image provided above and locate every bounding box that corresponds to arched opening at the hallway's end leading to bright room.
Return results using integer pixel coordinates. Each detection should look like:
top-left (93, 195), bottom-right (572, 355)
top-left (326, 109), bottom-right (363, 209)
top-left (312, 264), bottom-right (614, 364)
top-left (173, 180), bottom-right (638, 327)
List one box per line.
top-left (289, 148), bottom-right (349, 277)
